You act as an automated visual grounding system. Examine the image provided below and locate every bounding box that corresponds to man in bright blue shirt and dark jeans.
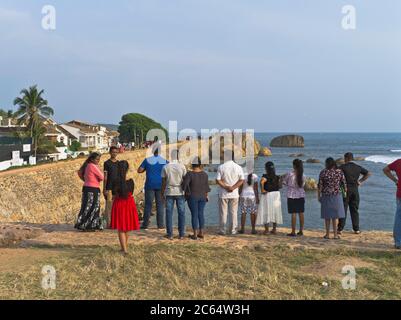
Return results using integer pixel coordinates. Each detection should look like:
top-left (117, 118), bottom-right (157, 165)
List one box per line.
top-left (138, 148), bottom-right (168, 229)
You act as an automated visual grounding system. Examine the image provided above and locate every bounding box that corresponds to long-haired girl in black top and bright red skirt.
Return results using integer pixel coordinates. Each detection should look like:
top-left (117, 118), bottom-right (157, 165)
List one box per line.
top-left (111, 161), bottom-right (139, 255)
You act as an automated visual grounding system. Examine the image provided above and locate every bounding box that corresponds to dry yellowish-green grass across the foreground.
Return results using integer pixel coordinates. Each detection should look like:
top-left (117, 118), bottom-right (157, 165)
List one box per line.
top-left (0, 243), bottom-right (401, 299)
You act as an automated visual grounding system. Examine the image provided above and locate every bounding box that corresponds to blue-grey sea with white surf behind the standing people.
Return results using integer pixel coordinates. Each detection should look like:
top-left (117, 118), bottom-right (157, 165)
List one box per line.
top-left (197, 133), bottom-right (401, 231)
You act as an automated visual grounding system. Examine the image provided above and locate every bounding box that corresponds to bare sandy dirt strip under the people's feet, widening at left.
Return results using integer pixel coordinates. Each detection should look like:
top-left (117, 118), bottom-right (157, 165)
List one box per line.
top-left (0, 224), bottom-right (395, 272)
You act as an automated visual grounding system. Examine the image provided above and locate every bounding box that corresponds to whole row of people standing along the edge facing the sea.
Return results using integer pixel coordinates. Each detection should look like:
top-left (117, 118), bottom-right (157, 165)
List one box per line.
top-left (75, 147), bottom-right (401, 254)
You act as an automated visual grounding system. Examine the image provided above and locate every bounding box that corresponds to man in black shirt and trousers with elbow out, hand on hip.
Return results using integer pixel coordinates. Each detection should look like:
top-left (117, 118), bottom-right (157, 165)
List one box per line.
top-left (338, 152), bottom-right (371, 234)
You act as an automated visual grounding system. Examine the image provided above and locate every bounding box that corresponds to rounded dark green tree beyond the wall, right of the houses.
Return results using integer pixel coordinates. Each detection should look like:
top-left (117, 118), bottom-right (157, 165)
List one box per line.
top-left (118, 113), bottom-right (167, 143)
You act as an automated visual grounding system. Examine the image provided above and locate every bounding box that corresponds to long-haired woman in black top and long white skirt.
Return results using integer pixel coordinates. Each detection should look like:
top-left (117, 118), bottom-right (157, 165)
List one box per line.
top-left (256, 161), bottom-right (283, 234)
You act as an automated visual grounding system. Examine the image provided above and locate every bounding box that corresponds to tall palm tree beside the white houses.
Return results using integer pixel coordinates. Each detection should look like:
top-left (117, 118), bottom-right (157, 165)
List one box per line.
top-left (14, 85), bottom-right (54, 157)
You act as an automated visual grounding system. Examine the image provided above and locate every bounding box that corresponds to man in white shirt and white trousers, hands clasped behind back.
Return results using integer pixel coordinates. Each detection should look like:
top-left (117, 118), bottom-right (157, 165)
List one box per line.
top-left (216, 152), bottom-right (245, 235)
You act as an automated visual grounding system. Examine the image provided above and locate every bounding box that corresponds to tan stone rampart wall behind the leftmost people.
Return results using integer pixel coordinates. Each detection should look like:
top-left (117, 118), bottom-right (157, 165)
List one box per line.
top-left (0, 150), bottom-right (146, 224)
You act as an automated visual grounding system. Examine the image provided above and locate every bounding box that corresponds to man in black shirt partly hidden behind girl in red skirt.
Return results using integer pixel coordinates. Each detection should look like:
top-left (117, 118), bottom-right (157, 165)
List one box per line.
top-left (103, 147), bottom-right (119, 228)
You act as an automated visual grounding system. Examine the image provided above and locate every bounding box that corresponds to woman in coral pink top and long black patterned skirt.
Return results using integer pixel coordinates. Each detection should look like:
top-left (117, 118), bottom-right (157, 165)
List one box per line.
top-left (75, 152), bottom-right (104, 231)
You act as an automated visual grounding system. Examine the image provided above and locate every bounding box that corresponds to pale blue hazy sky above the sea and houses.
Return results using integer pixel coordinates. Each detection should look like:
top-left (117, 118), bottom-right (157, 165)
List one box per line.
top-left (0, 0), bottom-right (401, 132)
